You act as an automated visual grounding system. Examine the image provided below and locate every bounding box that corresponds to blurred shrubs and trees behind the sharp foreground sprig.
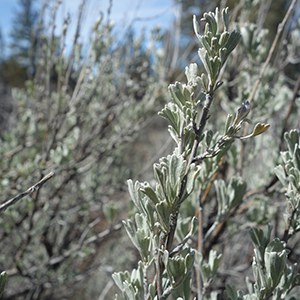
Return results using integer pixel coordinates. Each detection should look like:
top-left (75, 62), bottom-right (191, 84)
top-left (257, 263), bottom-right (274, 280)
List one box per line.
top-left (0, 0), bottom-right (300, 299)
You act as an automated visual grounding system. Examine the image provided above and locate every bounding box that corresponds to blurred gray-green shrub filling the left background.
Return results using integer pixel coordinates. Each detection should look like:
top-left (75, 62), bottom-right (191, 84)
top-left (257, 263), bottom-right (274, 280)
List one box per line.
top-left (0, 1), bottom-right (163, 298)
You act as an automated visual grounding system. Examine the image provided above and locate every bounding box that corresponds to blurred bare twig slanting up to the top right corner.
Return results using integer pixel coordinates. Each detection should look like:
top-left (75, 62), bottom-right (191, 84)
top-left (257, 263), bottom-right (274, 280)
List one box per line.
top-left (248, 0), bottom-right (297, 102)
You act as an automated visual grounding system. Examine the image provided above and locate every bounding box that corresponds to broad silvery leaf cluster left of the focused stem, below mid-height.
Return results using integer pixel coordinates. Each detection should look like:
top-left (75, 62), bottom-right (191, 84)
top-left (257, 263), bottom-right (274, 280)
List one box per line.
top-left (124, 154), bottom-right (200, 236)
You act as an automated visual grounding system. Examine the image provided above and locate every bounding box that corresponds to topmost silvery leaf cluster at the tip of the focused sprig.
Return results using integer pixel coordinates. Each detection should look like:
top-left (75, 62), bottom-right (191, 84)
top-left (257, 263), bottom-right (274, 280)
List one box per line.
top-left (193, 8), bottom-right (241, 91)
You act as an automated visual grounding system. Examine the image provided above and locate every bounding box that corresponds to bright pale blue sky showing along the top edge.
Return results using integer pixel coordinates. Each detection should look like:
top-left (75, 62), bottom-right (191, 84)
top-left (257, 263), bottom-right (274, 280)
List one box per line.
top-left (0, 0), bottom-right (176, 44)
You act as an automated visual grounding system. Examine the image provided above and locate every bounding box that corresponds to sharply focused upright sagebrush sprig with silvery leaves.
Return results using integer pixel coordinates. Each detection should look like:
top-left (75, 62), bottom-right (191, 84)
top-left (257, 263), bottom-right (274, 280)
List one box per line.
top-left (114, 9), bottom-right (267, 299)
